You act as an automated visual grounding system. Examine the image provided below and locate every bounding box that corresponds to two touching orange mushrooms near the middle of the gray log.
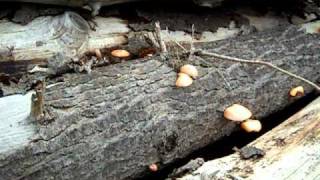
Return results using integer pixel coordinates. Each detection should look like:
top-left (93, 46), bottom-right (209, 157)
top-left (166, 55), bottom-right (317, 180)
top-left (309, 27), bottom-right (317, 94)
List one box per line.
top-left (176, 64), bottom-right (198, 87)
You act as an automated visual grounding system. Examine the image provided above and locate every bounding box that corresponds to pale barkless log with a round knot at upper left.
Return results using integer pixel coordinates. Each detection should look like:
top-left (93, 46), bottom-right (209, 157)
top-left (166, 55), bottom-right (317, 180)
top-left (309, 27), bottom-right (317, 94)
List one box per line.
top-left (0, 12), bottom-right (130, 63)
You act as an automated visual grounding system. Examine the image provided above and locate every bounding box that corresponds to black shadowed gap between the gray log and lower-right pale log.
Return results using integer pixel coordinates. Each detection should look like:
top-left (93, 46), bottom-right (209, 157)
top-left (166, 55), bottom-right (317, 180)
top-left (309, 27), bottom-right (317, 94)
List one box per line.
top-left (136, 92), bottom-right (319, 180)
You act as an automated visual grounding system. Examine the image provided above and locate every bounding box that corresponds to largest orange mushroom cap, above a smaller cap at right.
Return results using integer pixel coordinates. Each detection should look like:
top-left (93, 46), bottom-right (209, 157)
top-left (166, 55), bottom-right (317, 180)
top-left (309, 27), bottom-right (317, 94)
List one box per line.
top-left (223, 104), bottom-right (252, 122)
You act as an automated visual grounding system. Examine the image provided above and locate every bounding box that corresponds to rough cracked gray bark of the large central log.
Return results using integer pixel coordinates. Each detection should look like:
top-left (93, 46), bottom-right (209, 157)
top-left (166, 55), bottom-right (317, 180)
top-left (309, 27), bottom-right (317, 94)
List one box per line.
top-left (0, 24), bottom-right (320, 180)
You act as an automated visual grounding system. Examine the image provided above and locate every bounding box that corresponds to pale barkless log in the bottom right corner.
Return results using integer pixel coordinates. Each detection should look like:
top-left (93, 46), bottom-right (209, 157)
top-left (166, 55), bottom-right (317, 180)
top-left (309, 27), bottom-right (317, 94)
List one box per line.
top-left (180, 98), bottom-right (320, 180)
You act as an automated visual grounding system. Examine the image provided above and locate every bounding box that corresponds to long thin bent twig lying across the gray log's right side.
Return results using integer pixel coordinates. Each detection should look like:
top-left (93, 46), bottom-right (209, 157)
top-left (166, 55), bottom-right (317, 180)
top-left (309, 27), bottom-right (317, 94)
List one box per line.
top-left (196, 50), bottom-right (320, 92)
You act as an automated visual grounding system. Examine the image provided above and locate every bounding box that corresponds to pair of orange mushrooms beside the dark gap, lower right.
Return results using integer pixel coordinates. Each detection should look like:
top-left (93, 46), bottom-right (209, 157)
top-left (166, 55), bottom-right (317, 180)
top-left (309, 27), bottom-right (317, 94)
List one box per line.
top-left (223, 104), bottom-right (262, 133)
